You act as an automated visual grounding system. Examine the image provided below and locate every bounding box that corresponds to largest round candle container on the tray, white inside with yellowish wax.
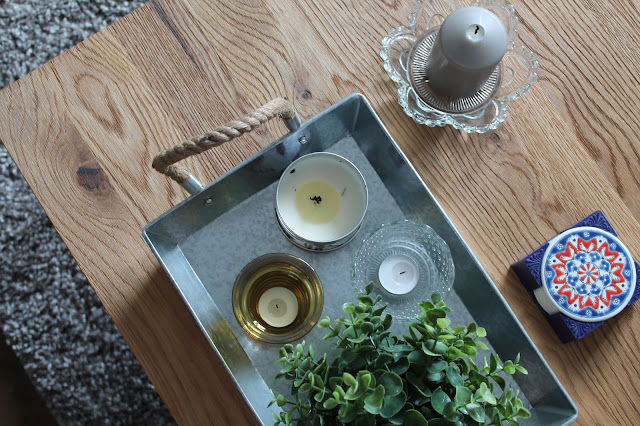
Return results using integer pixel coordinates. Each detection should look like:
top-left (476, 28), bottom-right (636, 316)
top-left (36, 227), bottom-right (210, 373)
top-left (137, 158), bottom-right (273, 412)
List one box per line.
top-left (276, 152), bottom-right (368, 251)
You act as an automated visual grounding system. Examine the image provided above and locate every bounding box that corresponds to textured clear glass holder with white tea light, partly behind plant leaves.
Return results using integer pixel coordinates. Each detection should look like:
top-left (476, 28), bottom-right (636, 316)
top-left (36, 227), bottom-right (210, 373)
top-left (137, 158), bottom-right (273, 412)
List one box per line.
top-left (351, 220), bottom-right (455, 319)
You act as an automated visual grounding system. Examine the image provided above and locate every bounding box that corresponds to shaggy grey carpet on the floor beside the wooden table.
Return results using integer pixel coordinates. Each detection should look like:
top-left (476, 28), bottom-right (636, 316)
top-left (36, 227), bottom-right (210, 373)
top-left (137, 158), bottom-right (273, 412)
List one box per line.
top-left (0, 0), bottom-right (174, 425)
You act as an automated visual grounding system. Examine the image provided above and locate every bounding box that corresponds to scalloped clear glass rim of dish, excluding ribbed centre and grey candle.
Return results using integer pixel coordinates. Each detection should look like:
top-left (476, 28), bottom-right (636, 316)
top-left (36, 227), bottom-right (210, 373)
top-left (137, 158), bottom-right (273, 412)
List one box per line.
top-left (380, 0), bottom-right (539, 133)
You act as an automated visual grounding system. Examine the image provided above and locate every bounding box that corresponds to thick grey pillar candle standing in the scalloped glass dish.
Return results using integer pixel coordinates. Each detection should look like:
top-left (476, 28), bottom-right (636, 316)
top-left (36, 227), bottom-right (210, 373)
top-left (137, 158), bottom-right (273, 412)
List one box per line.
top-left (427, 6), bottom-right (508, 98)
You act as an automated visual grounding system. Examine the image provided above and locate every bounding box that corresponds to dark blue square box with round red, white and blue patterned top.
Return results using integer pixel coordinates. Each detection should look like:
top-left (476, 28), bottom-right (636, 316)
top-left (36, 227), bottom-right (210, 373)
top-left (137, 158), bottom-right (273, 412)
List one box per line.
top-left (511, 210), bottom-right (640, 343)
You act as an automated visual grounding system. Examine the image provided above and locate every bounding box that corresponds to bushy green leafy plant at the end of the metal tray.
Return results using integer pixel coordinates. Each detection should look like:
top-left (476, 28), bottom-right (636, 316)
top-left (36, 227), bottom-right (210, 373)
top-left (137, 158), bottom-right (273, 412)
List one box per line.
top-left (269, 284), bottom-right (530, 425)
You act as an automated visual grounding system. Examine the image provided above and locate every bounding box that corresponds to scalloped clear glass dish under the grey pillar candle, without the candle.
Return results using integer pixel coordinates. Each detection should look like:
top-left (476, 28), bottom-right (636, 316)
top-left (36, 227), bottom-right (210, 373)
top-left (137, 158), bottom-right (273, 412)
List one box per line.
top-left (380, 0), bottom-right (539, 133)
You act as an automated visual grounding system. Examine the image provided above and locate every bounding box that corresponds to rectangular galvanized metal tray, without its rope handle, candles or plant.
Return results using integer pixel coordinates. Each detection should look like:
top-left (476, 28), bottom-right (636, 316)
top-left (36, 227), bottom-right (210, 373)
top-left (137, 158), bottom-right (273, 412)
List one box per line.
top-left (143, 94), bottom-right (577, 425)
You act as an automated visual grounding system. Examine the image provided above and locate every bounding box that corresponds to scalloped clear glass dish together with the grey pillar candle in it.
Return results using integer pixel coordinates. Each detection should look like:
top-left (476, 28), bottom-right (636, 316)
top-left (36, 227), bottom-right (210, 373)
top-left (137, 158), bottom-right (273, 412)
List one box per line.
top-left (380, 0), bottom-right (539, 133)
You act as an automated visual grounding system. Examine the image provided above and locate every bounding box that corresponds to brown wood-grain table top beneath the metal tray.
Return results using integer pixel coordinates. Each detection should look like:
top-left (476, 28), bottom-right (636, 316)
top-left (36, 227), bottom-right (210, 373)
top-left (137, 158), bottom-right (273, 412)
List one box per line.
top-left (0, 0), bottom-right (640, 425)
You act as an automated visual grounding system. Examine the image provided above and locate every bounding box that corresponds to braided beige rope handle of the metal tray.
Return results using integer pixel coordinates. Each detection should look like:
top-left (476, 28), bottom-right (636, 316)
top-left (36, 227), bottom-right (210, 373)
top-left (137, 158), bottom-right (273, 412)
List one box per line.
top-left (151, 98), bottom-right (295, 183)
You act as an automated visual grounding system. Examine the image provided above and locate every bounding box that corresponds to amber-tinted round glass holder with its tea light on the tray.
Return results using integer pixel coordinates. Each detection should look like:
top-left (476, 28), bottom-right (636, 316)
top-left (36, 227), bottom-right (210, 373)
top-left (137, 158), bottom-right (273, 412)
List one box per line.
top-left (232, 253), bottom-right (324, 343)
